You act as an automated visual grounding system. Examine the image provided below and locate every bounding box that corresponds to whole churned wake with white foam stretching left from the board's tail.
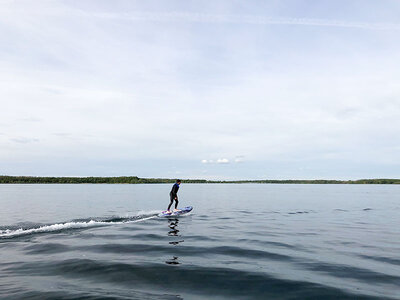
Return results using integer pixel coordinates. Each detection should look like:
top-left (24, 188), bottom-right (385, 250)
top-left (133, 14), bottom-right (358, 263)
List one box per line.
top-left (0, 211), bottom-right (159, 239)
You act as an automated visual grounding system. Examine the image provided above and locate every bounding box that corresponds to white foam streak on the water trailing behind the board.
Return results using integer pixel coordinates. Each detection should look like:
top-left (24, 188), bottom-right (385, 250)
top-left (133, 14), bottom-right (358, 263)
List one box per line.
top-left (0, 211), bottom-right (159, 238)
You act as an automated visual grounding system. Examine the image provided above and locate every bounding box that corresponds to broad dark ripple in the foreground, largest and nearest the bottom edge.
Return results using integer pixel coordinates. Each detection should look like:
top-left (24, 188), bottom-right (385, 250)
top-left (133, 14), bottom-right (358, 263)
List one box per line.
top-left (3, 259), bottom-right (384, 299)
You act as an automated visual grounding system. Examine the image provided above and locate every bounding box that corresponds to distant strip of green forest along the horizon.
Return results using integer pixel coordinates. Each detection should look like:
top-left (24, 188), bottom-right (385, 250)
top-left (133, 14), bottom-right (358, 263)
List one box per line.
top-left (0, 176), bottom-right (400, 184)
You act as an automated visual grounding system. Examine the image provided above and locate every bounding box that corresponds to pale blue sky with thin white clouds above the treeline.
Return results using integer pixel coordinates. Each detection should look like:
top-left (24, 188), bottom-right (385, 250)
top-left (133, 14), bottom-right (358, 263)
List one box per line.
top-left (0, 0), bottom-right (400, 180)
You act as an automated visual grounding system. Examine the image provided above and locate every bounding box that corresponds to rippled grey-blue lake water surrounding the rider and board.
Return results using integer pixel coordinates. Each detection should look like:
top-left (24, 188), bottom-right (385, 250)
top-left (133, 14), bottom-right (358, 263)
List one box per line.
top-left (0, 183), bottom-right (400, 299)
